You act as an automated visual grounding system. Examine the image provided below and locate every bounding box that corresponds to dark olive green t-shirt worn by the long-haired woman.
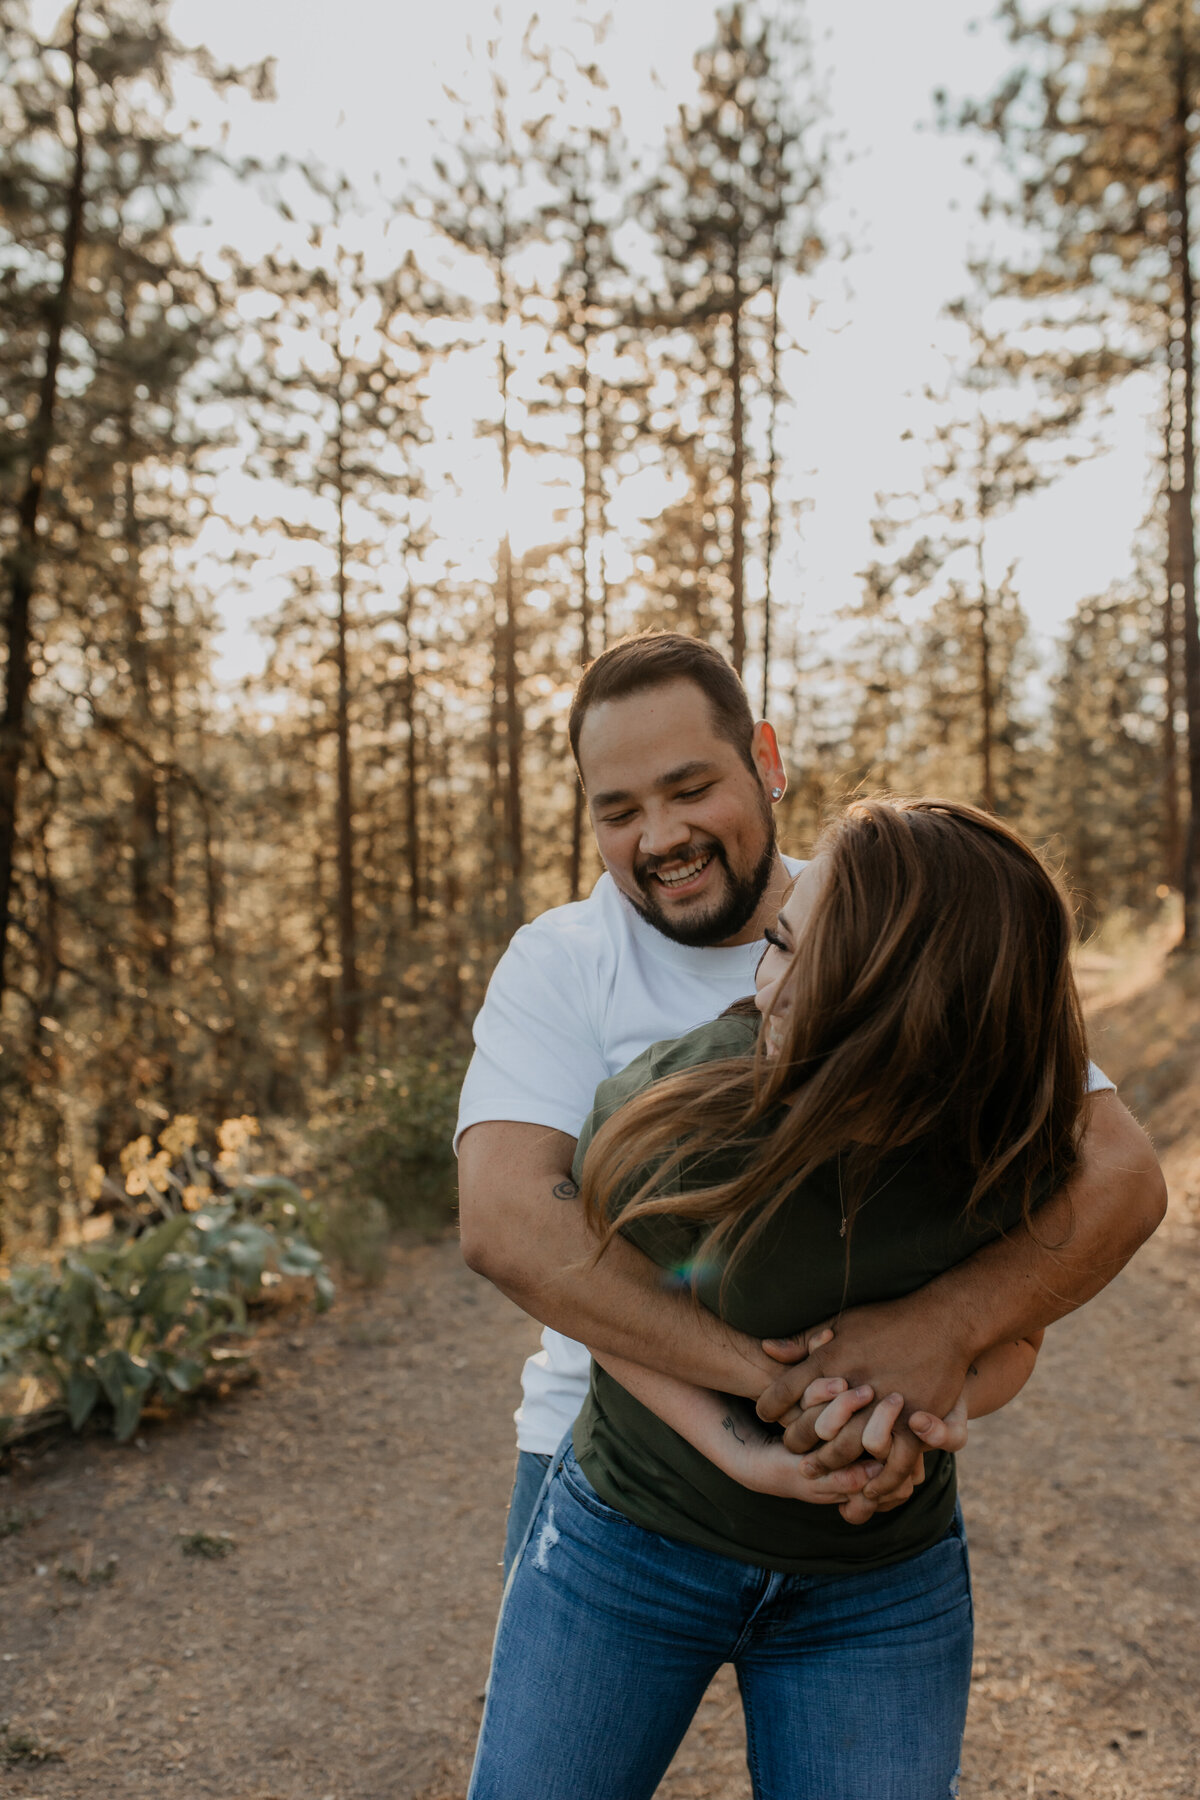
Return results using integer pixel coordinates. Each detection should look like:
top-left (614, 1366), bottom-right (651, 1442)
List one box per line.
top-left (574, 1017), bottom-right (1020, 1575)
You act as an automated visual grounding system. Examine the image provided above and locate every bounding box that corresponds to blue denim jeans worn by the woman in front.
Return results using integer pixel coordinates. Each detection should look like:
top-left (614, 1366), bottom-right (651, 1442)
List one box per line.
top-left (468, 1451), bottom-right (972, 1800)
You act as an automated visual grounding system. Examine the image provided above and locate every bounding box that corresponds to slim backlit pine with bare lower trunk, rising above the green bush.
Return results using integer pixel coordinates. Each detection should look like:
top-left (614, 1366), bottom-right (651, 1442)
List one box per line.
top-left (241, 171), bottom-right (432, 1066)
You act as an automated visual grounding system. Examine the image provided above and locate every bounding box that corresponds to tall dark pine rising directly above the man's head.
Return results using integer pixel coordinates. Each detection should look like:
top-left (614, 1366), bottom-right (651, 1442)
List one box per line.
top-left (646, 4), bottom-right (824, 673)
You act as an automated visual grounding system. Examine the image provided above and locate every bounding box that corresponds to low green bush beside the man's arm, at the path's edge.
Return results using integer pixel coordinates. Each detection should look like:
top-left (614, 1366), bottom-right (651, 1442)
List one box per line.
top-left (313, 1049), bottom-right (468, 1247)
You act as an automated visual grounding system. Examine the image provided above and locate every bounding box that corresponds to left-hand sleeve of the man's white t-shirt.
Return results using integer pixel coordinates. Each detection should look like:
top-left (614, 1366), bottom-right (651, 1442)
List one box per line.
top-left (453, 925), bottom-right (608, 1150)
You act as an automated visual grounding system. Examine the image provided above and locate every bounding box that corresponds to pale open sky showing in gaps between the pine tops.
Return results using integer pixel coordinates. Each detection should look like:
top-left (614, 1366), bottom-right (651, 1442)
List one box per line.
top-left (164, 0), bottom-right (1151, 675)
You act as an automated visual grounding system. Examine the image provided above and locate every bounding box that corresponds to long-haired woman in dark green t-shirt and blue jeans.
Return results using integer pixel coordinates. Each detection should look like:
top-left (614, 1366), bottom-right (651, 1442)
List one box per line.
top-left (470, 801), bottom-right (1087, 1800)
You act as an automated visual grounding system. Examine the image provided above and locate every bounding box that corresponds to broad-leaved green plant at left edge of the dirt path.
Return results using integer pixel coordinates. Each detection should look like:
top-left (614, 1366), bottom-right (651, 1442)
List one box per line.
top-left (0, 1177), bottom-right (333, 1442)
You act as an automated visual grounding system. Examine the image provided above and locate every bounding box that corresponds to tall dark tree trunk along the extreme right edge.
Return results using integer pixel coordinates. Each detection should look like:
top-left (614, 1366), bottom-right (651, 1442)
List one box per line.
top-left (1173, 32), bottom-right (1200, 945)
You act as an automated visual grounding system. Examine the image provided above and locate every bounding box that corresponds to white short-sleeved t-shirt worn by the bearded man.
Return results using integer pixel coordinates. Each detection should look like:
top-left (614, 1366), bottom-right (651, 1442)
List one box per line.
top-left (455, 857), bottom-right (1112, 1454)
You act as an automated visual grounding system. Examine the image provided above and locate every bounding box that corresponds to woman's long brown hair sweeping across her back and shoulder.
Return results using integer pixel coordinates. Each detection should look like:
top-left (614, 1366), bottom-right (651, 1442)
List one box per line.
top-left (583, 799), bottom-right (1087, 1262)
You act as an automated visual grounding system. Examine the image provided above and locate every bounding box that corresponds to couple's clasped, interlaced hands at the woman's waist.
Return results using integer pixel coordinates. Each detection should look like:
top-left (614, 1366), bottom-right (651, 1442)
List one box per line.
top-left (741, 1307), bottom-right (970, 1525)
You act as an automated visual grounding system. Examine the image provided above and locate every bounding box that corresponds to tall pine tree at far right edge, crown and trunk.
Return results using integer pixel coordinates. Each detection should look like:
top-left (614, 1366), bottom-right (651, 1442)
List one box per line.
top-left (963, 0), bottom-right (1200, 943)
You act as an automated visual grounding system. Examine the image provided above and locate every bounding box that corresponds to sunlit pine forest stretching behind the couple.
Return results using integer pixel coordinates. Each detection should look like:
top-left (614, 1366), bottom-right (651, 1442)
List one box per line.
top-left (0, 0), bottom-right (1200, 1260)
